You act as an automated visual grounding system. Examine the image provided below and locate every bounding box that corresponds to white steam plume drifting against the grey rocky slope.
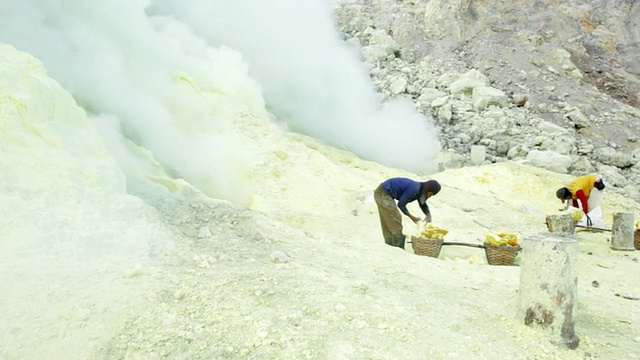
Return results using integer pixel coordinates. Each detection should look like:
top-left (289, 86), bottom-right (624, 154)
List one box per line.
top-left (150, 0), bottom-right (440, 170)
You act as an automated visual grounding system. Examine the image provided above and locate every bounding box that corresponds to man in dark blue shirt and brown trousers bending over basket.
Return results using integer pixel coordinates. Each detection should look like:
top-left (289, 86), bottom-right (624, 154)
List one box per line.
top-left (373, 177), bottom-right (440, 249)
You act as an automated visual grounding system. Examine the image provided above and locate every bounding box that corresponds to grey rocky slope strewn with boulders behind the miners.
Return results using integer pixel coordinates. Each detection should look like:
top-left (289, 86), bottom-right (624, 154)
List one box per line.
top-left (335, 0), bottom-right (640, 200)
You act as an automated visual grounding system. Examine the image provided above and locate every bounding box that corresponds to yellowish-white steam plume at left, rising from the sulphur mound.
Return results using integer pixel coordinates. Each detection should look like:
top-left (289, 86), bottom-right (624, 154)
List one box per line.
top-left (0, 0), bottom-right (266, 202)
